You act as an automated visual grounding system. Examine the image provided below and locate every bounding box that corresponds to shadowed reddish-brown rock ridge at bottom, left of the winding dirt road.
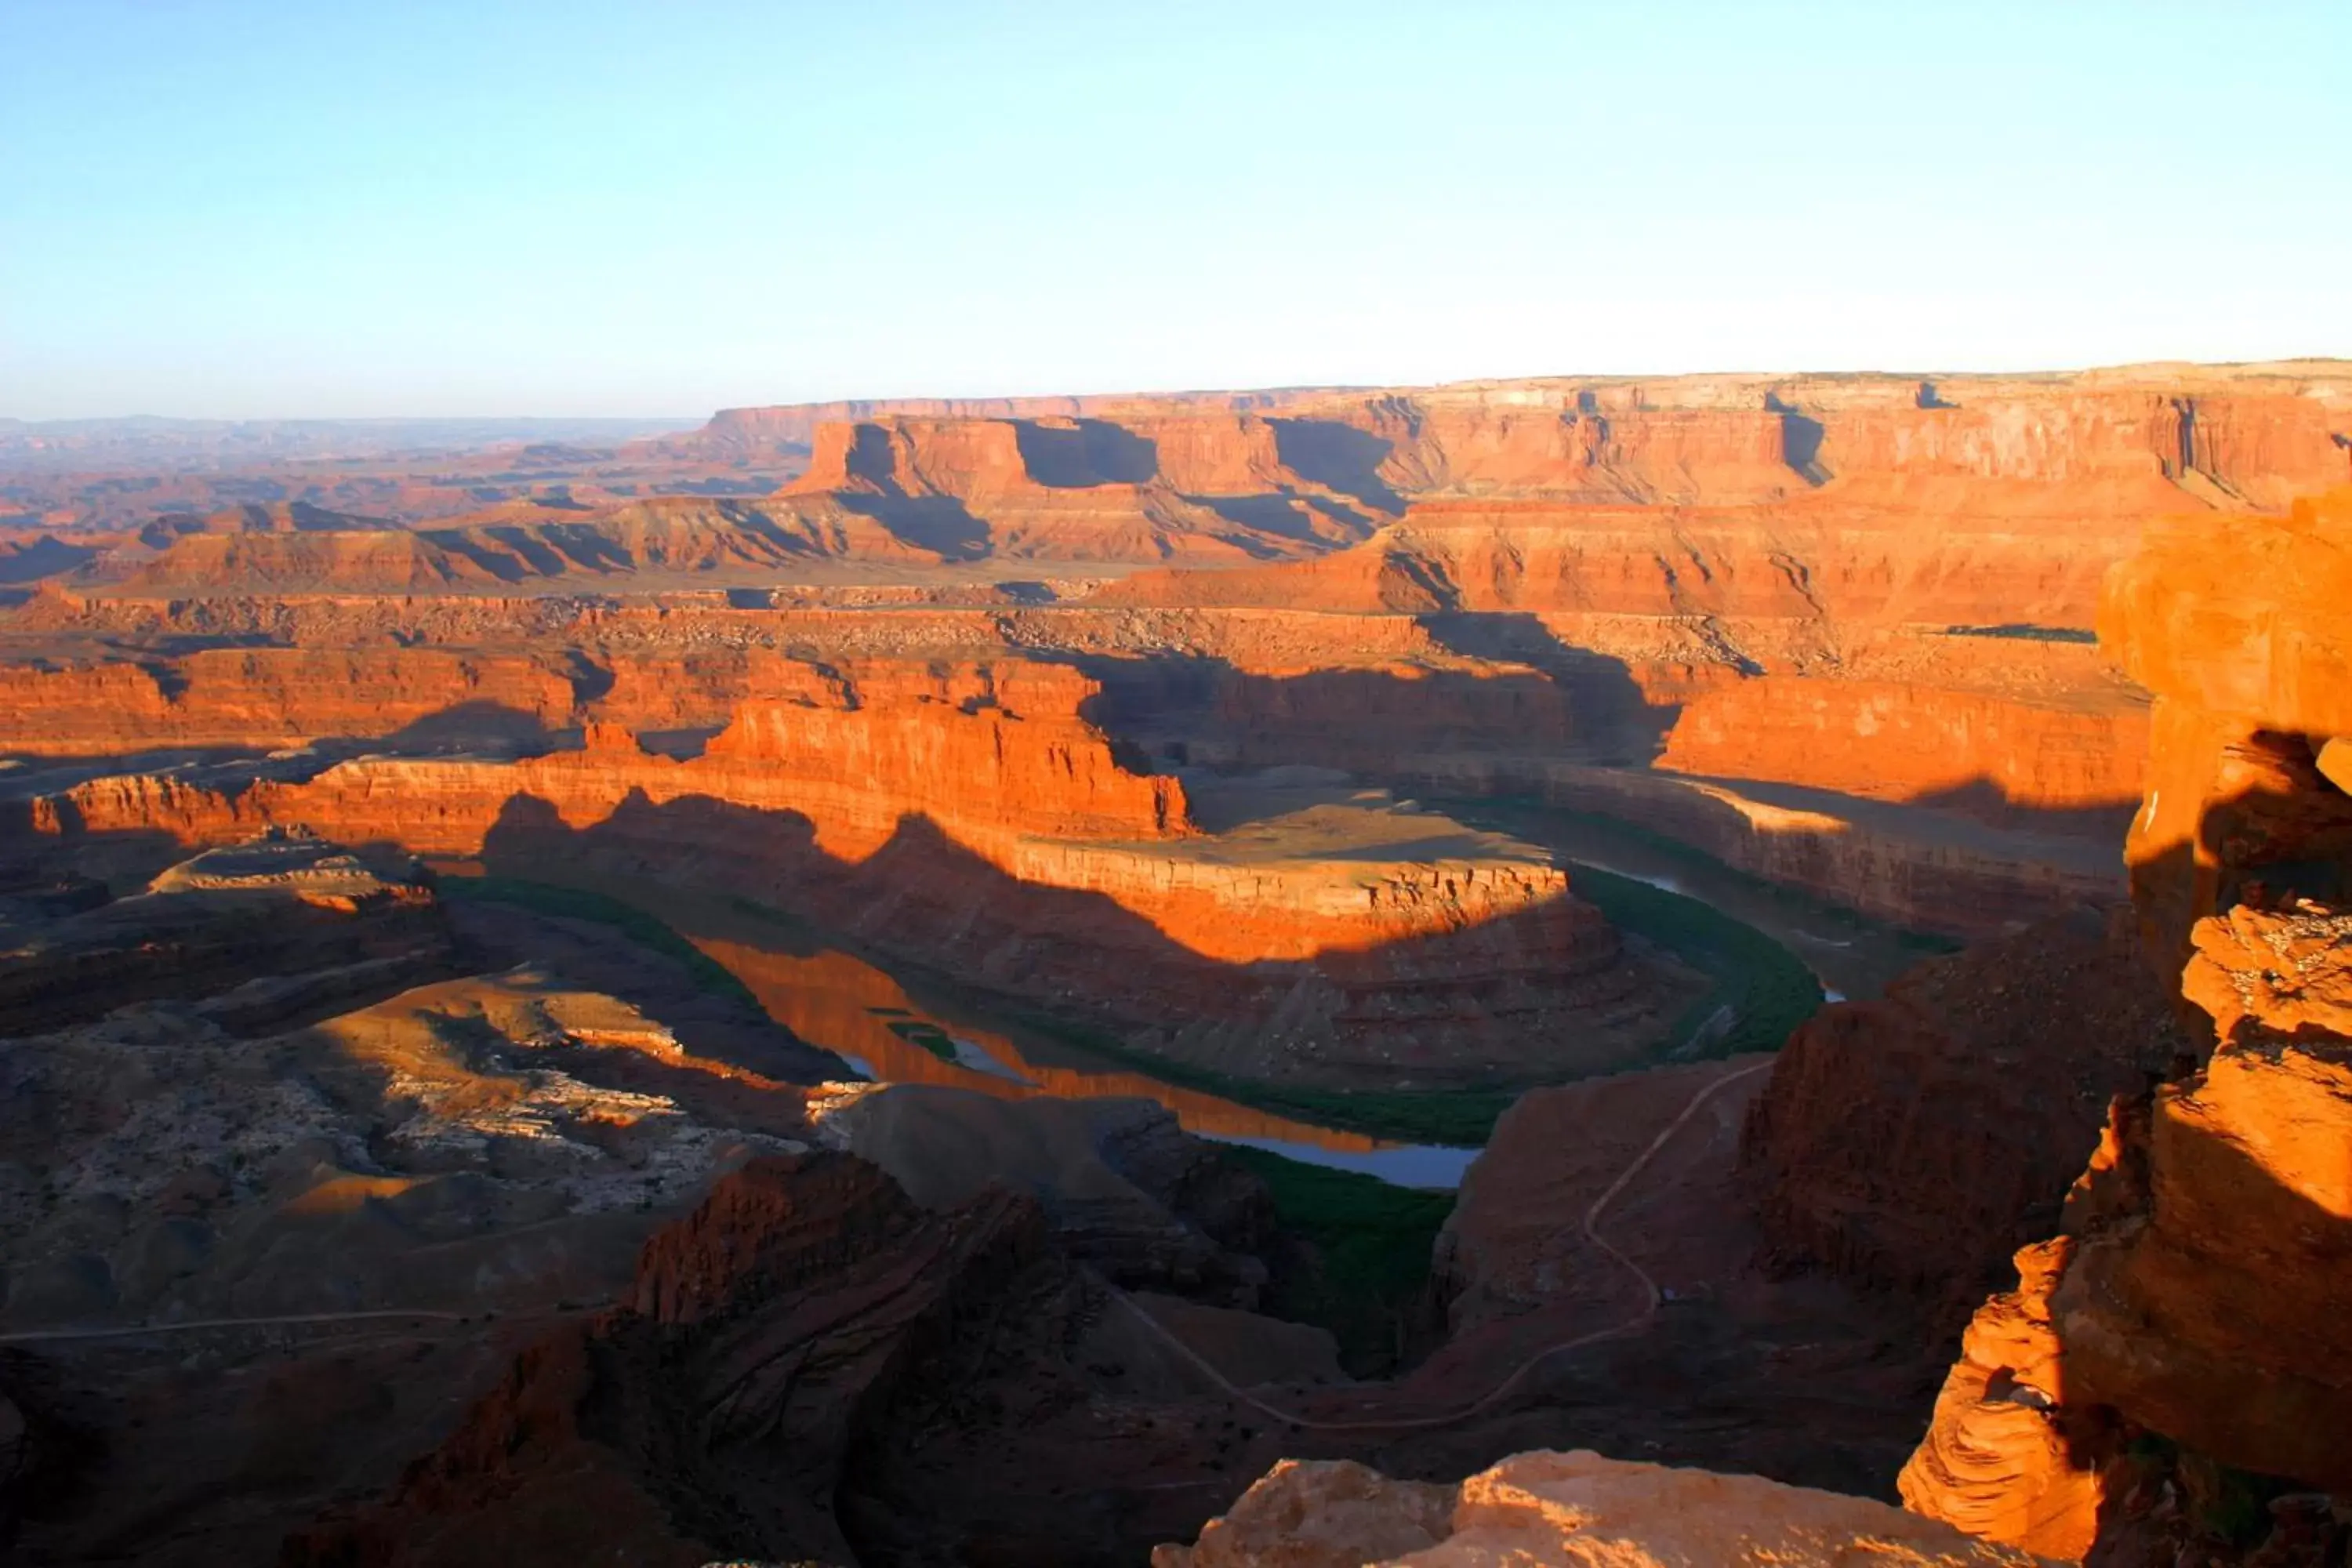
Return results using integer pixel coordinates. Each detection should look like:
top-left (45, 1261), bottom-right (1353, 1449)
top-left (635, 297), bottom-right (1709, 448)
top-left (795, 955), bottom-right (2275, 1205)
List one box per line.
top-left (280, 1156), bottom-right (1042, 1568)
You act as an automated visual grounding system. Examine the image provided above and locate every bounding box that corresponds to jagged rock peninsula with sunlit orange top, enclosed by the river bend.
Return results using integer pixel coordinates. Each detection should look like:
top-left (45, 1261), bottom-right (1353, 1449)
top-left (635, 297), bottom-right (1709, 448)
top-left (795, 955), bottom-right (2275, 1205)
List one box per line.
top-left (19, 661), bottom-right (1689, 1081)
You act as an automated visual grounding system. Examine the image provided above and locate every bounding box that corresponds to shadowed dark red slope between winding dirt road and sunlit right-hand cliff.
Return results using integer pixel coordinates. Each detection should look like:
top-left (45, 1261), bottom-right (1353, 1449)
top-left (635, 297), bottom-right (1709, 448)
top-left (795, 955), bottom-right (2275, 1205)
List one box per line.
top-left (1740, 907), bottom-right (2187, 1333)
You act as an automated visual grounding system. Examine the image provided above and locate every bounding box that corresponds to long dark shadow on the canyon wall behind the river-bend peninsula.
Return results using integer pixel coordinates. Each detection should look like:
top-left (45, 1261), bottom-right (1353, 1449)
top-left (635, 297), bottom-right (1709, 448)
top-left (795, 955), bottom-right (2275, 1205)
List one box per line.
top-left (1058, 644), bottom-right (2124, 940)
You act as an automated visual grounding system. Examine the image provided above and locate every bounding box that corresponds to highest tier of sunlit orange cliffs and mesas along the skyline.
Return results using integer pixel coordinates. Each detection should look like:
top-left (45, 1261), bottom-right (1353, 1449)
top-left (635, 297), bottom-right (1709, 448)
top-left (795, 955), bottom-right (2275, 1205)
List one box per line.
top-left (27, 365), bottom-right (2352, 594)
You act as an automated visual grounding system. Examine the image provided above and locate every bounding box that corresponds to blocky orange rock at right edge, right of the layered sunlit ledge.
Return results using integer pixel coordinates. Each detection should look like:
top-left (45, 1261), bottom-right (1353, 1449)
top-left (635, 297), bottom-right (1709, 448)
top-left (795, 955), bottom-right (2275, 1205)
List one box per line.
top-left (2051, 900), bottom-right (2352, 1495)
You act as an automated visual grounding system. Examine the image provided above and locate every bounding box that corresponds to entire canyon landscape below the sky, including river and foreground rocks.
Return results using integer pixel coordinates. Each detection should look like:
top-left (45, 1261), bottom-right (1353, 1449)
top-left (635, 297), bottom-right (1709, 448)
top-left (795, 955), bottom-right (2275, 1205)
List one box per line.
top-left (0, 360), bottom-right (2352, 1568)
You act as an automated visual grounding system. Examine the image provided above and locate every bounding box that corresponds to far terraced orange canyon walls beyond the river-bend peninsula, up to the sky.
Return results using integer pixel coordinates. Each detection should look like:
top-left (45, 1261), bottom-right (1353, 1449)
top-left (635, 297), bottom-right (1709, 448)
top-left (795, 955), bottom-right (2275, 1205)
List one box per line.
top-left (0, 365), bottom-right (2352, 973)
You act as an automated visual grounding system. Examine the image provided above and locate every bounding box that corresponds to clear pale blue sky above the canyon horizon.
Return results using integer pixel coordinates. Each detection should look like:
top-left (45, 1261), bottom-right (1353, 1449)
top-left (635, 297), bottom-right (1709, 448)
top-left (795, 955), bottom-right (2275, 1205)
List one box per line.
top-left (0, 0), bottom-right (2352, 419)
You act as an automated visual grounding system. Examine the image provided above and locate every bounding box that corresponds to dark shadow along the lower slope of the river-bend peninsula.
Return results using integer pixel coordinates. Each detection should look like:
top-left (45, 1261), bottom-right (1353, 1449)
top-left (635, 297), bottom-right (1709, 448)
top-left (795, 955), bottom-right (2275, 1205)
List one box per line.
top-left (482, 792), bottom-right (1639, 1088)
